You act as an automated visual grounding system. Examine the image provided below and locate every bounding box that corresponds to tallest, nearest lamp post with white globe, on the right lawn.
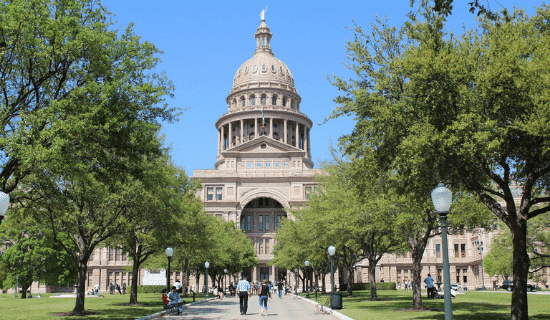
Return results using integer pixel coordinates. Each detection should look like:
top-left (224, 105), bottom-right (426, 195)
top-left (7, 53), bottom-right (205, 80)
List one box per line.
top-left (432, 183), bottom-right (453, 320)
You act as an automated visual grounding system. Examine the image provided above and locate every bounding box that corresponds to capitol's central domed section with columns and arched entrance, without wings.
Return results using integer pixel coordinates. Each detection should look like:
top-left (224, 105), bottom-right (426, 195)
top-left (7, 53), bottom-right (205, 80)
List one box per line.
top-left (193, 14), bottom-right (319, 281)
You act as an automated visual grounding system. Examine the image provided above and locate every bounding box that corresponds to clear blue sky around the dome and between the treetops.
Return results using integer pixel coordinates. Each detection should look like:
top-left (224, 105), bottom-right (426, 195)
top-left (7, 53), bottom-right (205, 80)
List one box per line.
top-left (102, 0), bottom-right (541, 175)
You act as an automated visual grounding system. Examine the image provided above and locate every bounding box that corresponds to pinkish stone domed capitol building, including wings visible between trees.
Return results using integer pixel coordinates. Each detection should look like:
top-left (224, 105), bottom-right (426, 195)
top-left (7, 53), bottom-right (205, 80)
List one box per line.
top-left (24, 14), bottom-right (548, 293)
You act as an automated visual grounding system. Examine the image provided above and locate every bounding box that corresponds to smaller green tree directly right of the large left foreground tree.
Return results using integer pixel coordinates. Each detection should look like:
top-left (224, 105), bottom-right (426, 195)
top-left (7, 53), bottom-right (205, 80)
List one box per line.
top-left (106, 157), bottom-right (202, 304)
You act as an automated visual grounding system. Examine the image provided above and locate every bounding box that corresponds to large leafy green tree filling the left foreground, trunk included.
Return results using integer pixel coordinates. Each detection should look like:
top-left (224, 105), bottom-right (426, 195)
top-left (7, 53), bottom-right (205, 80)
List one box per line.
top-left (0, 0), bottom-right (174, 313)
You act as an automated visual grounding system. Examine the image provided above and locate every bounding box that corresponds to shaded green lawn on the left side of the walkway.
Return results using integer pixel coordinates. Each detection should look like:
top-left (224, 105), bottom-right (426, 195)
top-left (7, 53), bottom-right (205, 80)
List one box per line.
top-left (0, 293), bottom-right (204, 320)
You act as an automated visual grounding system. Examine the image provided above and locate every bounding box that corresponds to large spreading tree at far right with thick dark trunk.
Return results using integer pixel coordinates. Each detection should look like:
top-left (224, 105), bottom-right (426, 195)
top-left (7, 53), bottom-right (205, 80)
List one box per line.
top-left (334, 6), bottom-right (550, 319)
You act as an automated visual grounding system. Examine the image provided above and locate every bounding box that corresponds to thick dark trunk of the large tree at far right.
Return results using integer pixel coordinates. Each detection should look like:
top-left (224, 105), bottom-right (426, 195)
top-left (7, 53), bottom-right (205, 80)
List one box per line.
top-left (512, 220), bottom-right (529, 320)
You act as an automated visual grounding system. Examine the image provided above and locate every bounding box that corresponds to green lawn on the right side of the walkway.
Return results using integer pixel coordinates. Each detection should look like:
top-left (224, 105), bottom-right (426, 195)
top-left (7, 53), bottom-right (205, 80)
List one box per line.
top-left (302, 290), bottom-right (550, 320)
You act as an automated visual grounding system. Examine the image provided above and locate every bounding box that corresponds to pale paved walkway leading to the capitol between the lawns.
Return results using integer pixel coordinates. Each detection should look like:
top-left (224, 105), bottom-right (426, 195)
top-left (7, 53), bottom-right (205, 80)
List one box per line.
top-left (161, 295), bottom-right (344, 320)
